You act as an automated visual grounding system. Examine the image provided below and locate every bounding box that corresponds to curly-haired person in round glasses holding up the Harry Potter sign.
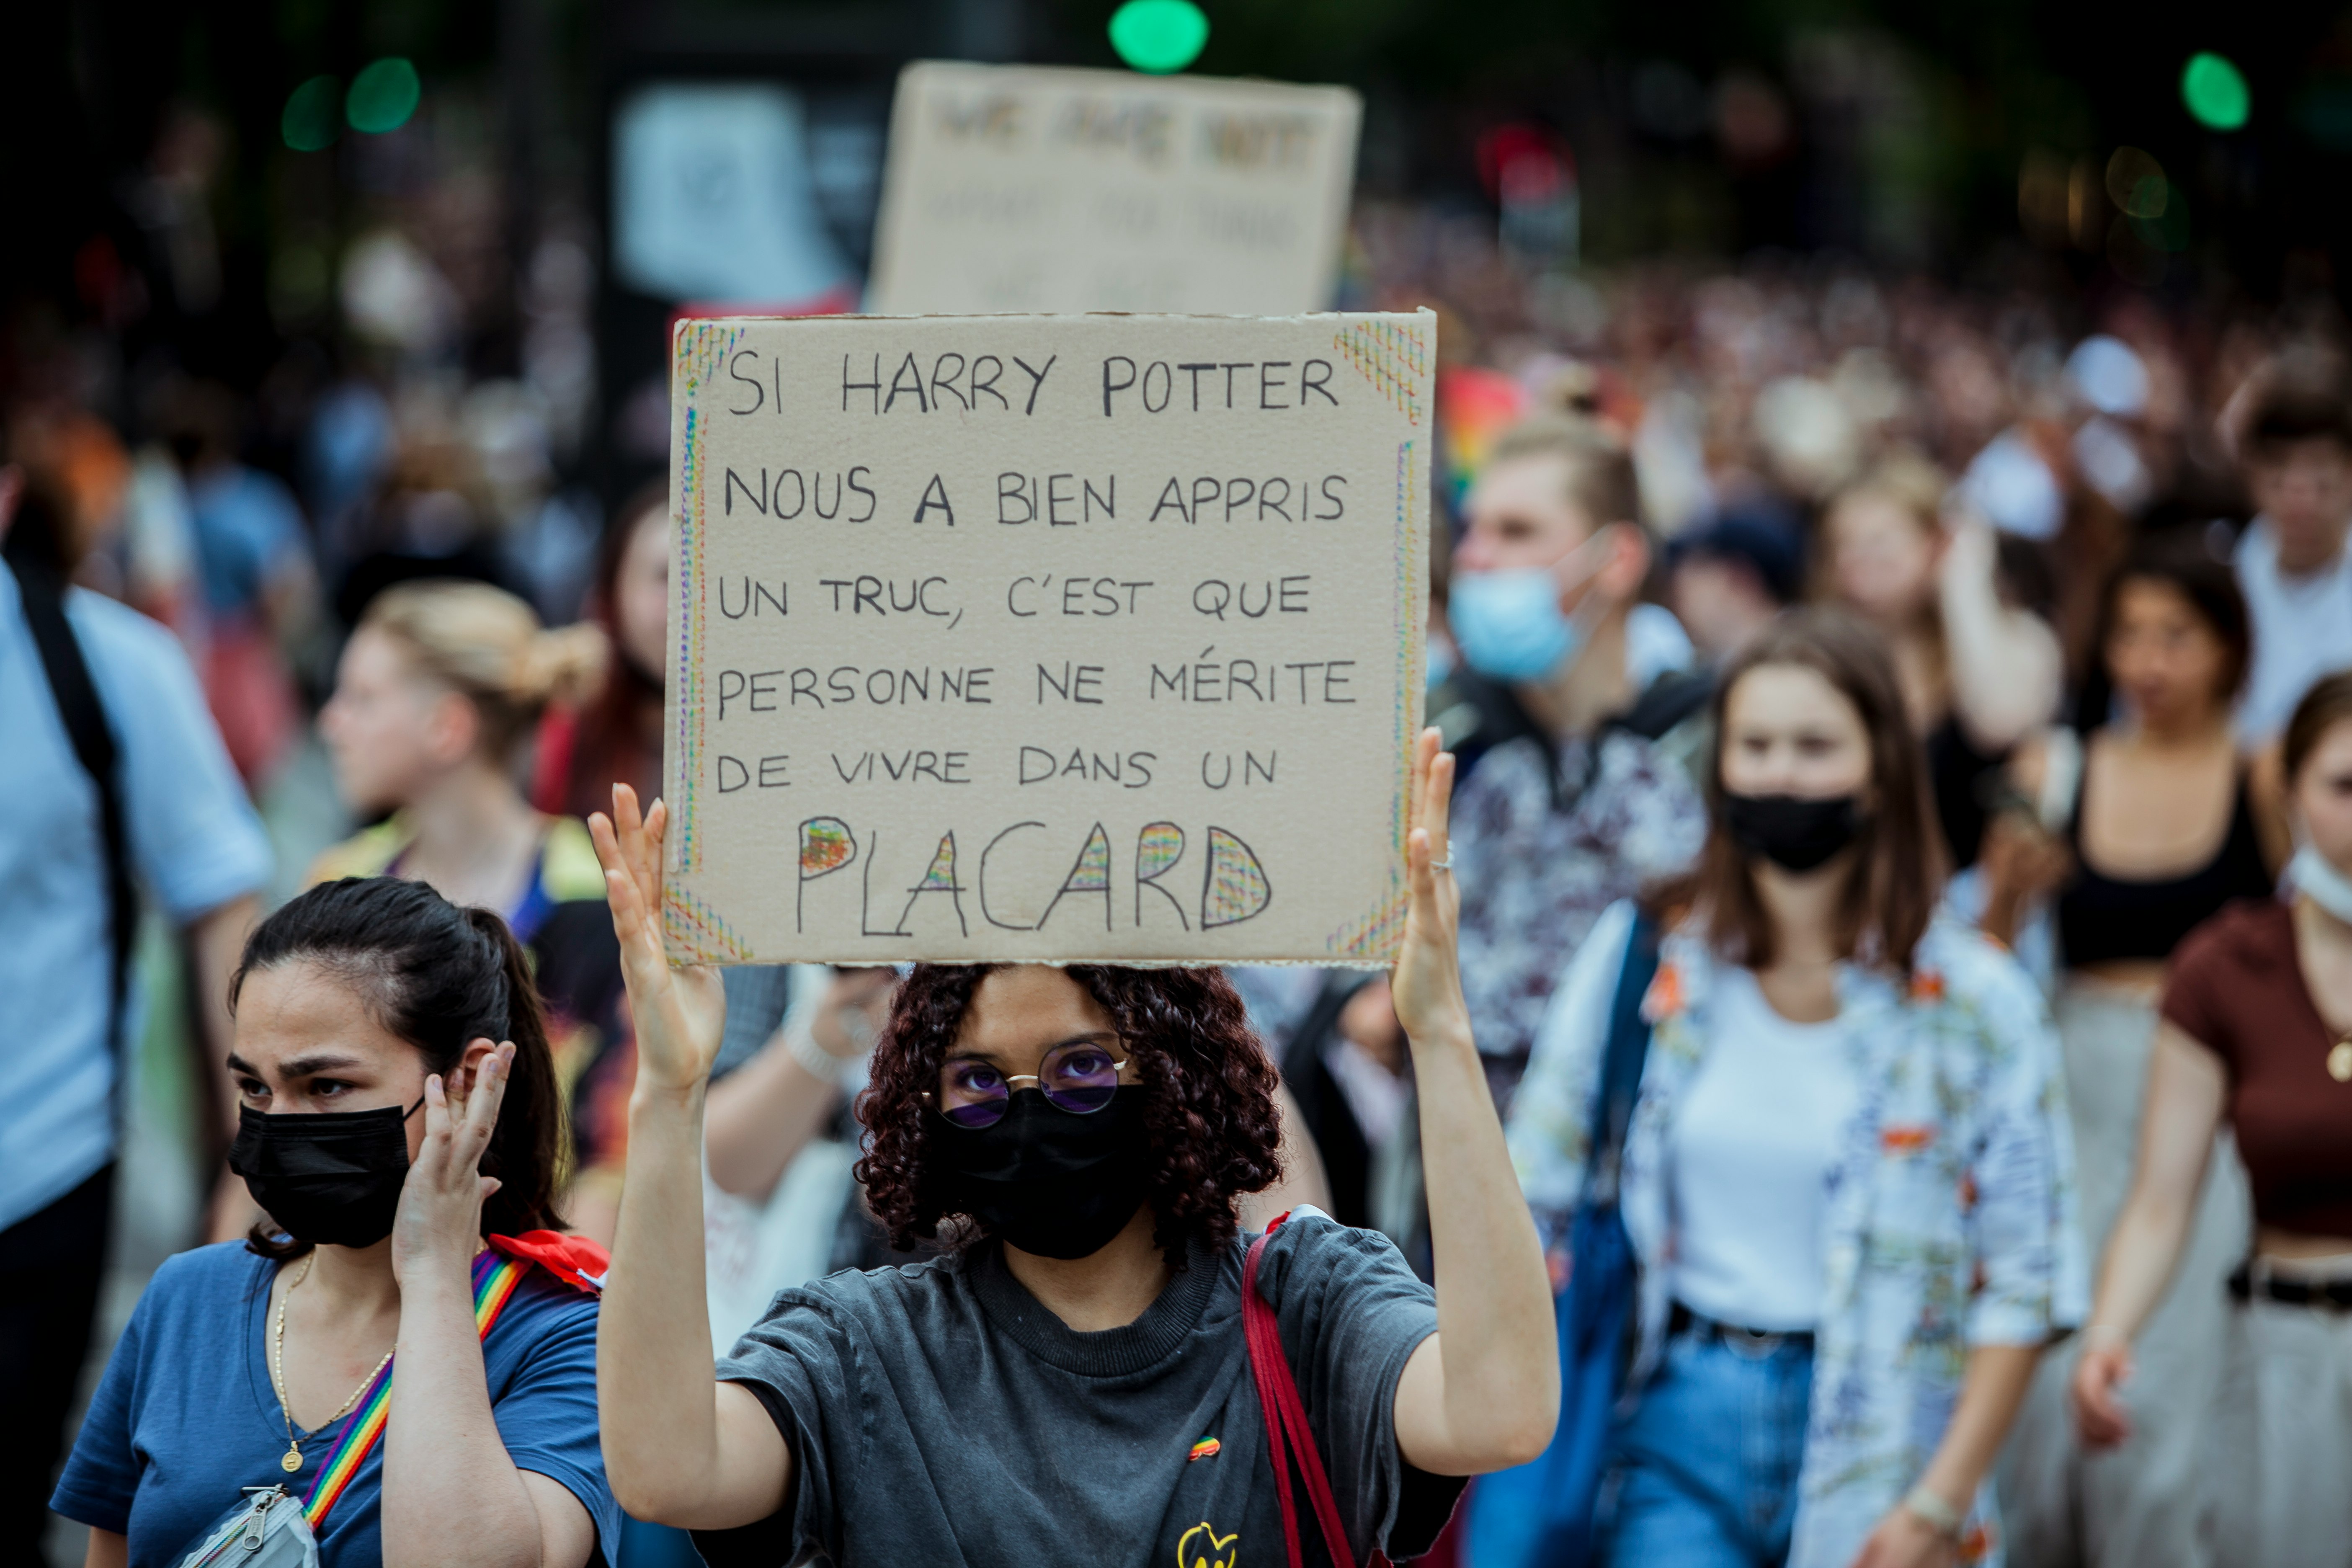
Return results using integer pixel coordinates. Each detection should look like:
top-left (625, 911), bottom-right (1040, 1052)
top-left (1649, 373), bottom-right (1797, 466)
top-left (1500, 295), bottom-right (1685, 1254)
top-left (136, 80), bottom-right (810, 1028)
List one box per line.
top-left (593, 731), bottom-right (1559, 1568)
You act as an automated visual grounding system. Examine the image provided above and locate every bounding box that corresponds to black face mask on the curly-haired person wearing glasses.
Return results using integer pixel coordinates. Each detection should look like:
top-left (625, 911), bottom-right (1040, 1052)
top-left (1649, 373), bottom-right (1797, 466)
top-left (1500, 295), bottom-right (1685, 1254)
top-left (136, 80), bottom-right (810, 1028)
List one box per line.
top-left (931, 1084), bottom-right (1148, 1258)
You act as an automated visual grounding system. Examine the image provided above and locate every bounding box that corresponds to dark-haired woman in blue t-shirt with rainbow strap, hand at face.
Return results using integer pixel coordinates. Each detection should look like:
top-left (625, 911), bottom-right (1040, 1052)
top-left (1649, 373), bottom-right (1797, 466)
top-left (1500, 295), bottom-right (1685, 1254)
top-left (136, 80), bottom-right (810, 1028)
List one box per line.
top-left (52, 877), bottom-right (621, 1568)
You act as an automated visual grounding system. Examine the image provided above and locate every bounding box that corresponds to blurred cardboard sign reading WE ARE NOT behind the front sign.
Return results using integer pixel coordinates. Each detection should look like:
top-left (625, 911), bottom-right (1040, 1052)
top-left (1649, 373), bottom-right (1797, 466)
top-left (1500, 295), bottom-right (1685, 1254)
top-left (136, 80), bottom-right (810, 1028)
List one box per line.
top-left (866, 61), bottom-right (1362, 315)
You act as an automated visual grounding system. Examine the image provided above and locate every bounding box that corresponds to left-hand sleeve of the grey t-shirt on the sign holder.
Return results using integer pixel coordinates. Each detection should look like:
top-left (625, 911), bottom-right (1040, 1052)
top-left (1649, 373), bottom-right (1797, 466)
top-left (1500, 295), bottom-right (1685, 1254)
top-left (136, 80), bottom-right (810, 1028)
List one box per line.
top-left (694, 1291), bottom-right (861, 1568)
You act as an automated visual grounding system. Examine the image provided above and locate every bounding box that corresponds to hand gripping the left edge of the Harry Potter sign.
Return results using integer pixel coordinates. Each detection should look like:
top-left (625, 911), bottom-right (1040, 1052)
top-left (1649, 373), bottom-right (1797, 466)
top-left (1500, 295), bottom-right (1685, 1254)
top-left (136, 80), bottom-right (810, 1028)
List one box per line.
top-left (588, 785), bottom-right (727, 1093)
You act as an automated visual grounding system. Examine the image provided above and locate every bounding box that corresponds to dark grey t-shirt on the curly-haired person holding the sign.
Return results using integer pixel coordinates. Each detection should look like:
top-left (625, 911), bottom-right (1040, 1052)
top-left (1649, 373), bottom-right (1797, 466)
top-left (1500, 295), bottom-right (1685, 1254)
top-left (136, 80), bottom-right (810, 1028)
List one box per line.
top-left (696, 1211), bottom-right (1463, 1568)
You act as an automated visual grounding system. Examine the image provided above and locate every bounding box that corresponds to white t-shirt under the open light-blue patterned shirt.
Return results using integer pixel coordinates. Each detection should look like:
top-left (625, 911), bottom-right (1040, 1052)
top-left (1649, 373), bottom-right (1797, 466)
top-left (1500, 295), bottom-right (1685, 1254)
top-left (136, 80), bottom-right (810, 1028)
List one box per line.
top-left (1668, 966), bottom-right (1863, 1333)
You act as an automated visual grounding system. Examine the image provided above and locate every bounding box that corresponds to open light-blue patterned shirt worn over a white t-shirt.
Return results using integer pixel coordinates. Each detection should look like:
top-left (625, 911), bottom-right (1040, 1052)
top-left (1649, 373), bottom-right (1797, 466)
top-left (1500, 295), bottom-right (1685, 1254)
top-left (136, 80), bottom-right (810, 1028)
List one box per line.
top-left (1510, 905), bottom-right (2089, 1568)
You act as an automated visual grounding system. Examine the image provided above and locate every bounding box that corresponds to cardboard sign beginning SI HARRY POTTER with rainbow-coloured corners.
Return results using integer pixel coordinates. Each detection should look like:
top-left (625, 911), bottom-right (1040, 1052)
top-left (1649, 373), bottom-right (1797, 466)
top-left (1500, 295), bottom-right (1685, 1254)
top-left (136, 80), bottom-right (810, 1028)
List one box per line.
top-left (663, 310), bottom-right (1437, 964)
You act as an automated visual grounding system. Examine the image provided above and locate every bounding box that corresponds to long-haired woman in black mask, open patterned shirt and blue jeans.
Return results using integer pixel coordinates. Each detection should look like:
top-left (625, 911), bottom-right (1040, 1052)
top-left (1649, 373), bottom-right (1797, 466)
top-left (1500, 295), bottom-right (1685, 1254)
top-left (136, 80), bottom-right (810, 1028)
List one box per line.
top-left (1510, 611), bottom-right (2081, 1568)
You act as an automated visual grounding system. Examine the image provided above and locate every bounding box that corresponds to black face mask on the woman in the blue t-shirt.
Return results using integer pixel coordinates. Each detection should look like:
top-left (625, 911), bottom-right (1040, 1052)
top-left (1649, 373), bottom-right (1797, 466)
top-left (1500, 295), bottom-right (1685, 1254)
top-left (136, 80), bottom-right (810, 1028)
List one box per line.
top-left (228, 1100), bottom-right (423, 1246)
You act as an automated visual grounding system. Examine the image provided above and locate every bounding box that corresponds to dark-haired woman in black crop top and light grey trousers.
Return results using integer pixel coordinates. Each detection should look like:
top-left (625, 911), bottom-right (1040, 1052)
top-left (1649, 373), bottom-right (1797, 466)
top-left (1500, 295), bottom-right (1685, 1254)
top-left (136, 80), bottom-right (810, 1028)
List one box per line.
top-left (1981, 536), bottom-right (2277, 1568)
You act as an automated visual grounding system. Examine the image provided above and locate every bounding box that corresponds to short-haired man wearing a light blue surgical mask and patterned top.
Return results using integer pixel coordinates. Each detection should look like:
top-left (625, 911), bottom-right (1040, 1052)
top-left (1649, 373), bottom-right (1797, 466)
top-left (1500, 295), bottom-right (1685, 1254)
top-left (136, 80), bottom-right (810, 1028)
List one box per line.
top-left (1439, 416), bottom-right (1710, 1103)
